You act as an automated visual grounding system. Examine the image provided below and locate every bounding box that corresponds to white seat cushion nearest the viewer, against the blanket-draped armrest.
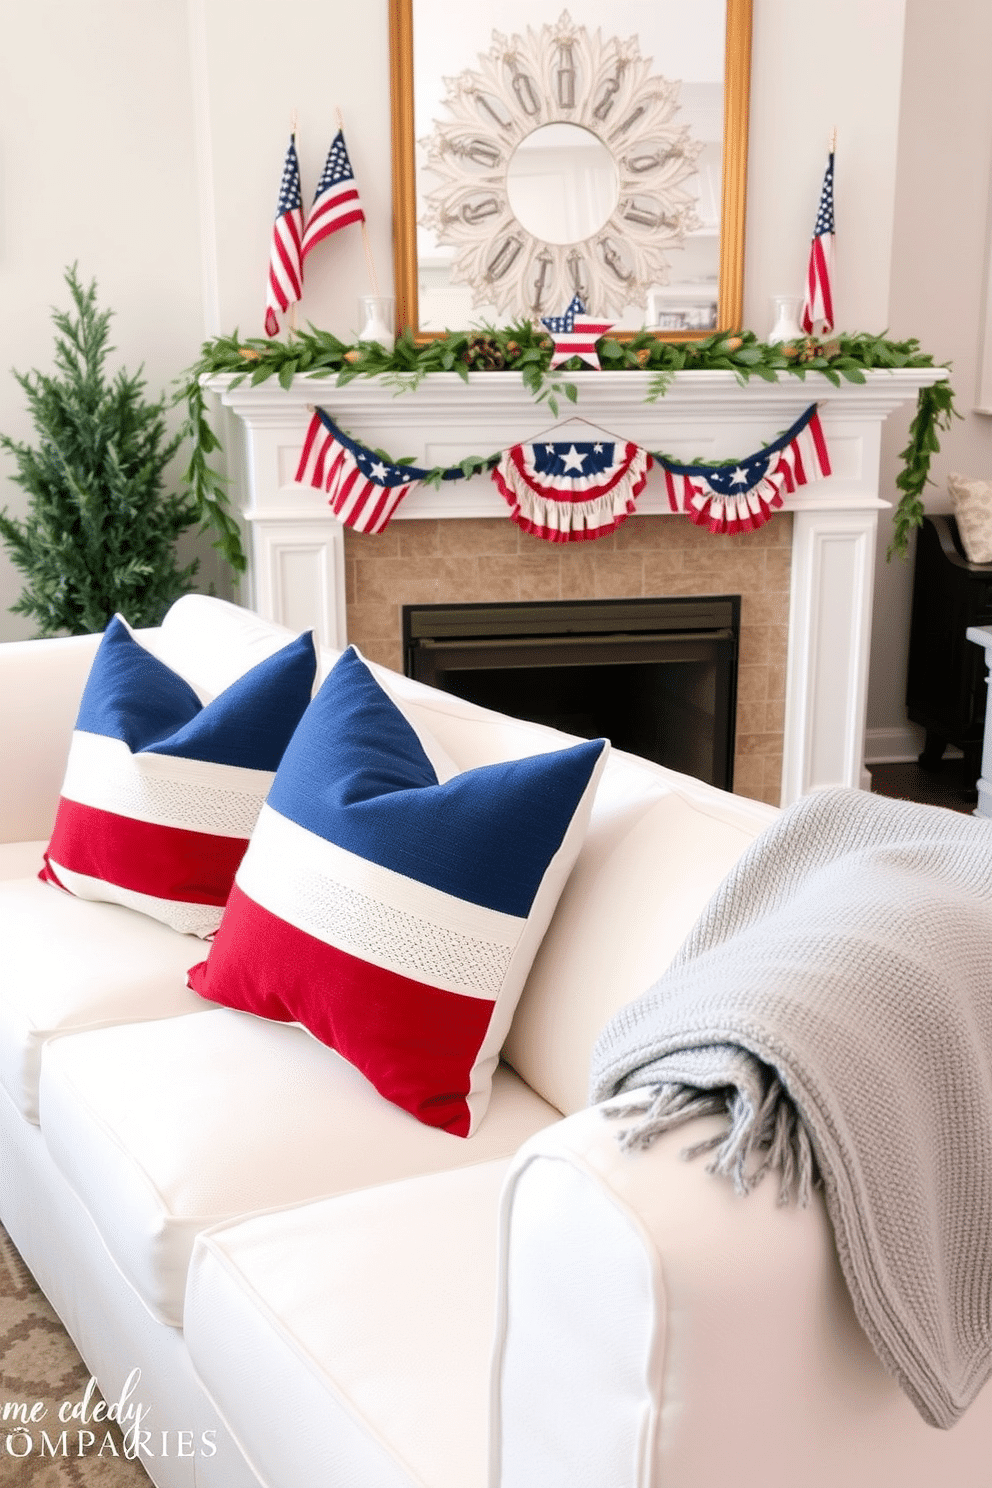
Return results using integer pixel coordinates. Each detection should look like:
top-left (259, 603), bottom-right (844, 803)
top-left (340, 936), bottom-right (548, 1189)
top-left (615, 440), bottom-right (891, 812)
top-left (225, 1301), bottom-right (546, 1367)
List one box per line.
top-left (184, 1162), bottom-right (507, 1488)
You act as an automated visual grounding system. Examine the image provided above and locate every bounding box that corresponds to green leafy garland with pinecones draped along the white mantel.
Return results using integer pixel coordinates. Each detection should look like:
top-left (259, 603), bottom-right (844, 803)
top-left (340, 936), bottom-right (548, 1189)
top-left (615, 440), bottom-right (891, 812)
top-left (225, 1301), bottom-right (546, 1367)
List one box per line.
top-left (175, 321), bottom-right (956, 573)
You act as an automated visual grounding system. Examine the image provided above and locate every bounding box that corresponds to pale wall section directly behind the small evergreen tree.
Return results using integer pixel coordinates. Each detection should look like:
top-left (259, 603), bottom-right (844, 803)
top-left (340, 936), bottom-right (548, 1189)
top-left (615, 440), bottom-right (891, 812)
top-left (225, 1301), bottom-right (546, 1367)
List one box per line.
top-left (0, 0), bottom-right (214, 638)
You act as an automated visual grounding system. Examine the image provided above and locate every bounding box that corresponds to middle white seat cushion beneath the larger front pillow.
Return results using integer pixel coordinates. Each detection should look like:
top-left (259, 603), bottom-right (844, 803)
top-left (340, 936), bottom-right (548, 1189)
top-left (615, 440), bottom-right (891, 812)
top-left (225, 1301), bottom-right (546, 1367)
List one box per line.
top-left (40, 1009), bottom-right (559, 1327)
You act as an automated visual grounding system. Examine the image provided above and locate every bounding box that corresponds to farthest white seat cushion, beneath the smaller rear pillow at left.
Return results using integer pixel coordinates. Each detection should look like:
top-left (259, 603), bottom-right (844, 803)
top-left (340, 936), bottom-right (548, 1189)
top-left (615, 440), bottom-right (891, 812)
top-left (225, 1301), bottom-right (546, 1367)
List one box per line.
top-left (0, 875), bottom-right (210, 1122)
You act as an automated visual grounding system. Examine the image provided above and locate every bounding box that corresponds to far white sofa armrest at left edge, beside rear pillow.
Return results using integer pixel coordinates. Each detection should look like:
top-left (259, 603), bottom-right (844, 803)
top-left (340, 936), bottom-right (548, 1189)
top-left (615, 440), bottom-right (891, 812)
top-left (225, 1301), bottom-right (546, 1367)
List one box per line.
top-left (0, 635), bottom-right (100, 842)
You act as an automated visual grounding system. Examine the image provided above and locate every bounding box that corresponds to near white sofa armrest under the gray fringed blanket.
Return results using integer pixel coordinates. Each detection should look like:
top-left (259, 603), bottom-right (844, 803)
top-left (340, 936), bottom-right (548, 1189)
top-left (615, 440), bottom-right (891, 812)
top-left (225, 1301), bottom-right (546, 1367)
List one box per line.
top-left (489, 1103), bottom-right (992, 1488)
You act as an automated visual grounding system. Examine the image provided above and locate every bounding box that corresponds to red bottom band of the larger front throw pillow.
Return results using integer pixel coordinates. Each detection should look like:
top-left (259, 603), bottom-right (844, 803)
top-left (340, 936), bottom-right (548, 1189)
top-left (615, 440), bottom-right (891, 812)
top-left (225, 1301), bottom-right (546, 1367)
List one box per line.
top-left (189, 884), bottom-right (494, 1137)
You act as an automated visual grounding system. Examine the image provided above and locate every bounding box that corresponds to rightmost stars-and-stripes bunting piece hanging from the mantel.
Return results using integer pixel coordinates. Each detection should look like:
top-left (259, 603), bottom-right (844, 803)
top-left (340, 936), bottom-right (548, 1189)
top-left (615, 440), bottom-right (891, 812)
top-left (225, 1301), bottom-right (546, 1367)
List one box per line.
top-left (656, 403), bottom-right (830, 533)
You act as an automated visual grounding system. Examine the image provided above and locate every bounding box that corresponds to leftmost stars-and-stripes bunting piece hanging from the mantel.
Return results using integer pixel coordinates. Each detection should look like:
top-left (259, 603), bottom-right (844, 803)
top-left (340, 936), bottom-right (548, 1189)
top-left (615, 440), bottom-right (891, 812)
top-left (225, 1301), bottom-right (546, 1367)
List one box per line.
top-left (293, 408), bottom-right (422, 533)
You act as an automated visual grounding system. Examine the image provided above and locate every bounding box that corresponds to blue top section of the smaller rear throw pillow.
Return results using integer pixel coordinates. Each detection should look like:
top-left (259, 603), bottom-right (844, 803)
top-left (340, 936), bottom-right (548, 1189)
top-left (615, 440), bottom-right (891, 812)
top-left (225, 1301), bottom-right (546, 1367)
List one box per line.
top-left (76, 616), bottom-right (317, 771)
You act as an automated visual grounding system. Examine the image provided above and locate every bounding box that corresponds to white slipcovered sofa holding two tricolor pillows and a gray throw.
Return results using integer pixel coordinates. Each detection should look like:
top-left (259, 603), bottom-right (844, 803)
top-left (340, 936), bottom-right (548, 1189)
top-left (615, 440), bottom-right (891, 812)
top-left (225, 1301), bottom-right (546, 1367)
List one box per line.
top-left (0, 597), bottom-right (992, 1488)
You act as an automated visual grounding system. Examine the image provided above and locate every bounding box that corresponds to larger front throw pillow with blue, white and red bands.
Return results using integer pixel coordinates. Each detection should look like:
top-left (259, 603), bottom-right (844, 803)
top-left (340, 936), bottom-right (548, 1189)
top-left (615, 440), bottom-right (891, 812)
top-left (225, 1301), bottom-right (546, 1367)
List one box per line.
top-left (182, 649), bottom-right (610, 1137)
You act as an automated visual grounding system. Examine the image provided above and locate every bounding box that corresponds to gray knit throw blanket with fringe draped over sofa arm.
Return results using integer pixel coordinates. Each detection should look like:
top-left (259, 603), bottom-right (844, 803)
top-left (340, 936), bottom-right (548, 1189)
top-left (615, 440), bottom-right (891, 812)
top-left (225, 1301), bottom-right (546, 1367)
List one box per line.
top-left (590, 790), bottom-right (992, 1427)
